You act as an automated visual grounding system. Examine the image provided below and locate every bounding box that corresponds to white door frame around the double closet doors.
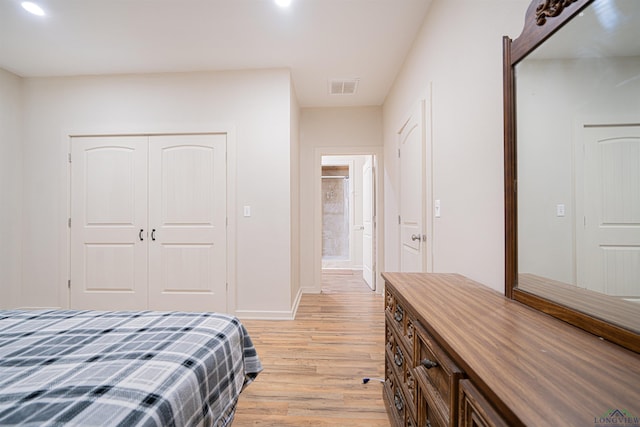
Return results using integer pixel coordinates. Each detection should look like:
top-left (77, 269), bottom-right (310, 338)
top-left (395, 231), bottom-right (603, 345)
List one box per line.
top-left (58, 124), bottom-right (237, 315)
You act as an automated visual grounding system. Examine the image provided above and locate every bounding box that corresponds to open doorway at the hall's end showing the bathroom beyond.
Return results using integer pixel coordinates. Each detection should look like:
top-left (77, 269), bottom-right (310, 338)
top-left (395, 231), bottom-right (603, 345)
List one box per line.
top-left (317, 153), bottom-right (378, 290)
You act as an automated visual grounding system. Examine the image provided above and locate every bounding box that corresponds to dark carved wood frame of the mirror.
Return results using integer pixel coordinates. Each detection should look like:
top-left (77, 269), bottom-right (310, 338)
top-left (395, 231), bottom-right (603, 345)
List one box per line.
top-left (503, 0), bottom-right (640, 353)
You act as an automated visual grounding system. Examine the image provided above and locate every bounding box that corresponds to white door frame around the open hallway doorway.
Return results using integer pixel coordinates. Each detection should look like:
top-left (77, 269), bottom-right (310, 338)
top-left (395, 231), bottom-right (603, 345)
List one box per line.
top-left (313, 146), bottom-right (384, 293)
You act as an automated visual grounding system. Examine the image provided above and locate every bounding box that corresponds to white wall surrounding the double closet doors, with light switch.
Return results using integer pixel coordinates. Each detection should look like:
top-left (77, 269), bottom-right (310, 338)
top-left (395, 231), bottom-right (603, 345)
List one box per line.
top-left (21, 70), bottom-right (292, 317)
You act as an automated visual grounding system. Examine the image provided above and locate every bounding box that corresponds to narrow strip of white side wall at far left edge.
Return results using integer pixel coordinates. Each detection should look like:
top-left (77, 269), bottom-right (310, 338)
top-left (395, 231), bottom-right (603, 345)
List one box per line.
top-left (0, 68), bottom-right (22, 308)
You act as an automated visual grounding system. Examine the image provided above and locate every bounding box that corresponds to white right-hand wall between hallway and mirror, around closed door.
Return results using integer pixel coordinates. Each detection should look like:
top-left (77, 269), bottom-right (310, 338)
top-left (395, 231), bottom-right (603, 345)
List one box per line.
top-left (383, 0), bottom-right (529, 292)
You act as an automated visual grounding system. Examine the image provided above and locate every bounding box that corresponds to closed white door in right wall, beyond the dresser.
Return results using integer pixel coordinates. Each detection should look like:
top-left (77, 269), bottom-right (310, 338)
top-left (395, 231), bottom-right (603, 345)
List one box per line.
top-left (399, 104), bottom-right (425, 272)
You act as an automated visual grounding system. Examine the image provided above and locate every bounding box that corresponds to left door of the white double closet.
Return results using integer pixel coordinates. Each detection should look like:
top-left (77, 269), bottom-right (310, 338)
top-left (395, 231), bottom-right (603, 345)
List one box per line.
top-left (70, 136), bottom-right (148, 310)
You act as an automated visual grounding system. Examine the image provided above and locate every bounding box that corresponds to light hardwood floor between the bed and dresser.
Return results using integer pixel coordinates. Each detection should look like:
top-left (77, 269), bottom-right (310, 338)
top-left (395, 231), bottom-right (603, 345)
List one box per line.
top-left (233, 271), bottom-right (389, 427)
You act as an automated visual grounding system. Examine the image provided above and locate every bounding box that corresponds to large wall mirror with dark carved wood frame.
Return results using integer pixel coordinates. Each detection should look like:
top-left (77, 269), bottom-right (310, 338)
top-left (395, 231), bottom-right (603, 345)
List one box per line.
top-left (503, 0), bottom-right (640, 352)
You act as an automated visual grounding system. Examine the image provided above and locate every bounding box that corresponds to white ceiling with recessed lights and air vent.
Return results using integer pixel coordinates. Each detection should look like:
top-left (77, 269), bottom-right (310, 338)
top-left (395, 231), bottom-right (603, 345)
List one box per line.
top-left (0, 0), bottom-right (431, 107)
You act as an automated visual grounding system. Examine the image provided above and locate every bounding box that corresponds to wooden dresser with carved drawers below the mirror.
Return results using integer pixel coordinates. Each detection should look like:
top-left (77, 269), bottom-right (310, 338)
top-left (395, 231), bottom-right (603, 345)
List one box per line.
top-left (382, 273), bottom-right (640, 427)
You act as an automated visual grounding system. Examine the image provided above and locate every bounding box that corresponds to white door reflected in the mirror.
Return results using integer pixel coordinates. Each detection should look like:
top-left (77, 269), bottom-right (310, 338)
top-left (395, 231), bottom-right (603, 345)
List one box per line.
top-left (576, 125), bottom-right (640, 298)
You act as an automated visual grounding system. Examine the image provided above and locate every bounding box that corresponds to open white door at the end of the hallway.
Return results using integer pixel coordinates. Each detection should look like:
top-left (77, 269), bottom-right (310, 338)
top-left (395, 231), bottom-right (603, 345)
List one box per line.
top-left (362, 156), bottom-right (376, 291)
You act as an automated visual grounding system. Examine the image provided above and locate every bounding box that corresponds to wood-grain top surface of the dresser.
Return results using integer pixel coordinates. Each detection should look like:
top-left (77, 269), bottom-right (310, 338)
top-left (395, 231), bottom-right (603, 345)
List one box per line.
top-left (382, 273), bottom-right (640, 426)
